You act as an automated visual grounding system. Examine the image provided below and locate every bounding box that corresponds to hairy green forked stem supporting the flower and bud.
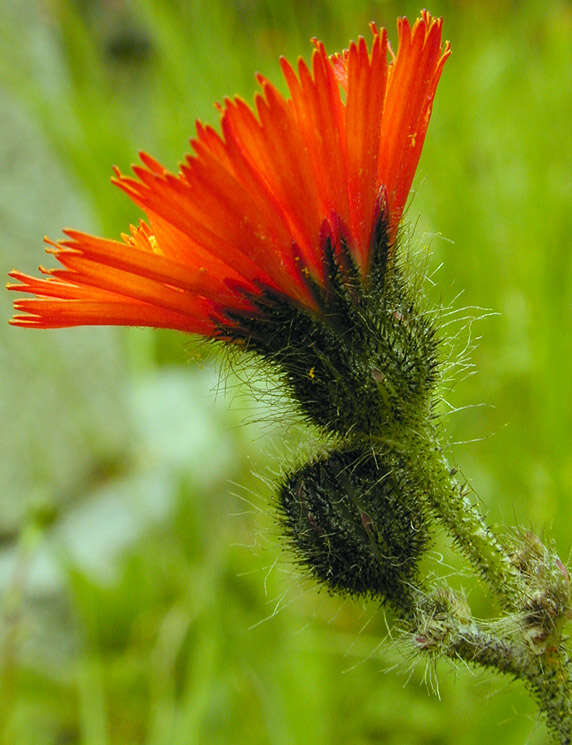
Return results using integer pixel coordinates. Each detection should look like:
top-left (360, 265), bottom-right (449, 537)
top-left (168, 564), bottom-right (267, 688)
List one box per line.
top-left (402, 428), bottom-right (572, 745)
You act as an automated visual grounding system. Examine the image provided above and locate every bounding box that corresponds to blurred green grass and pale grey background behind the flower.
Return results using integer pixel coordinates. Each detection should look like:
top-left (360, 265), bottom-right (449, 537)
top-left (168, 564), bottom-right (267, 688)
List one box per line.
top-left (0, 0), bottom-right (572, 745)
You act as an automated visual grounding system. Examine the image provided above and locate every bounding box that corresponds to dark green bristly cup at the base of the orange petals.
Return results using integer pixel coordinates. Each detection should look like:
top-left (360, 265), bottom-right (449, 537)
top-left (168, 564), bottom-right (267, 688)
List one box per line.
top-left (224, 212), bottom-right (437, 438)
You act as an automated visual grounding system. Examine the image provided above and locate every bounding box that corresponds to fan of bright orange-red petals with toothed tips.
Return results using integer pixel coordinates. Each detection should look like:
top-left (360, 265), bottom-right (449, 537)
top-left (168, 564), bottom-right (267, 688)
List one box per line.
top-left (8, 11), bottom-right (450, 338)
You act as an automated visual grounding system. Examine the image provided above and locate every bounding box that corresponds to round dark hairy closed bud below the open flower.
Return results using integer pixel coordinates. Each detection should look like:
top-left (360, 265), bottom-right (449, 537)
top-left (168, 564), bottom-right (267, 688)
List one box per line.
top-left (280, 450), bottom-right (428, 612)
